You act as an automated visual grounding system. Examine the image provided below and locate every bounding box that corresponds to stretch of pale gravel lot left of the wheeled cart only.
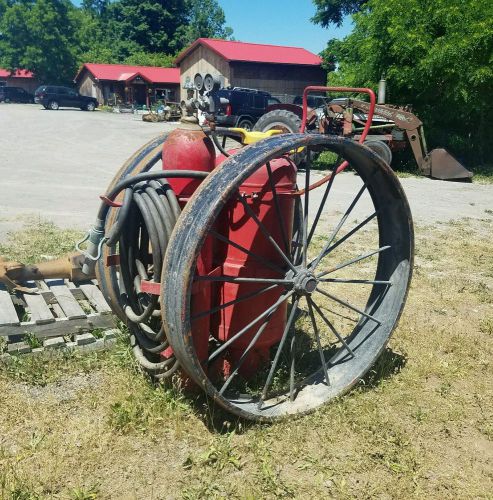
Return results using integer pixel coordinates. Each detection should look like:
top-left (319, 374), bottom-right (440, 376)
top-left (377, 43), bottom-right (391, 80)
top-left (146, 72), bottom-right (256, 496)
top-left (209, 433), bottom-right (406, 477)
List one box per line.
top-left (0, 104), bottom-right (179, 239)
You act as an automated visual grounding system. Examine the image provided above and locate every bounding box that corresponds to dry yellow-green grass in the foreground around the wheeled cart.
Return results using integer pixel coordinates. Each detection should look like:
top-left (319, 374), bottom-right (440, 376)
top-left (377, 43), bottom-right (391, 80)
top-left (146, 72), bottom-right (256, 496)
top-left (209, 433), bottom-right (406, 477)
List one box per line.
top-left (0, 219), bottom-right (493, 500)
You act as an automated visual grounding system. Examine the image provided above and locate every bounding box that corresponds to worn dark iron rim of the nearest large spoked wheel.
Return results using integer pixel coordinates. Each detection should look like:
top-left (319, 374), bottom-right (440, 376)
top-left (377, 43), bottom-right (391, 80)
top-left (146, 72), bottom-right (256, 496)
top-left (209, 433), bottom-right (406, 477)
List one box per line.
top-left (161, 134), bottom-right (413, 421)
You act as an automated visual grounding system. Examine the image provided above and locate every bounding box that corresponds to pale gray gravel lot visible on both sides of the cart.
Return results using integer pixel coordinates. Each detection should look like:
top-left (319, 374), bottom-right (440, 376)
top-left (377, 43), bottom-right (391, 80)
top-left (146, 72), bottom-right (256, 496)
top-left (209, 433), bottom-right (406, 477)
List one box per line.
top-left (0, 104), bottom-right (493, 240)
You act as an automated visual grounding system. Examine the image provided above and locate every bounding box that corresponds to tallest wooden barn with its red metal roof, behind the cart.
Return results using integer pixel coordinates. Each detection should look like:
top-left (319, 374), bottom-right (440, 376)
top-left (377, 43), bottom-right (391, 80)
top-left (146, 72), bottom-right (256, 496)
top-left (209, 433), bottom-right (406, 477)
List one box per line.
top-left (175, 38), bottom-right (327, 102)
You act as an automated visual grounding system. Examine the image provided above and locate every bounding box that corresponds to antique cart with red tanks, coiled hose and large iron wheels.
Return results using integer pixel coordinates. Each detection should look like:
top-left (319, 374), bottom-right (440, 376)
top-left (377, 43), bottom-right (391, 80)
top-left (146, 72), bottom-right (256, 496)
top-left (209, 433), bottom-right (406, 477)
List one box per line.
top-left (0, 75), bottom-right (414, 421)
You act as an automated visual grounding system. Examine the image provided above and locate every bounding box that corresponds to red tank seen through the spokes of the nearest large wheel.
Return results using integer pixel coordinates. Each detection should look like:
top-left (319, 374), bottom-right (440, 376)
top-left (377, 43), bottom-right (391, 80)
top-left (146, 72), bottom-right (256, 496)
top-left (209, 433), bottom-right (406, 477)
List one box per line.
top-left (211, 154), bottom-right (297, 378)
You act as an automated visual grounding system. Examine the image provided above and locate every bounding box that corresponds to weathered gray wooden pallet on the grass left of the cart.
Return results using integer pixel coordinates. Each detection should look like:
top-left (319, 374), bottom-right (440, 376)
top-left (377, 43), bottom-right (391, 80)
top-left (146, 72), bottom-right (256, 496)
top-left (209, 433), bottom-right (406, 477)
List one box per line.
top-left (0, 280), bottom-right (115, 340)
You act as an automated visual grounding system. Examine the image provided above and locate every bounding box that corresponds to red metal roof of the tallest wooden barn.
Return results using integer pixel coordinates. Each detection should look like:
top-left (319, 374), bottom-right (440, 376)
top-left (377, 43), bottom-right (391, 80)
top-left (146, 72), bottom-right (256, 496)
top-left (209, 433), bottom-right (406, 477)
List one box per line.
top-left (175, 38), bottom-right (322, 66)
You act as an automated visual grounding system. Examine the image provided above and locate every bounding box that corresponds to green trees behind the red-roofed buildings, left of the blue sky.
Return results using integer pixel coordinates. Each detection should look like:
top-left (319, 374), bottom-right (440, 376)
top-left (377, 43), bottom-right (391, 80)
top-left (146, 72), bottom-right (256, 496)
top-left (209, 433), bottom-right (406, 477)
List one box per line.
top-left (0, 0), bottom-right (232, 83)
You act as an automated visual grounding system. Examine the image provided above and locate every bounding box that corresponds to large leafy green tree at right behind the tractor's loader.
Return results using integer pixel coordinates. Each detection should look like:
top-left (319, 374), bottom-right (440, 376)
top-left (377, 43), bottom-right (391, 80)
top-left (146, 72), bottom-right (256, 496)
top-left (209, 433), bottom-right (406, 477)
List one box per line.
top-left (314, 0), bottom-right (493, 163)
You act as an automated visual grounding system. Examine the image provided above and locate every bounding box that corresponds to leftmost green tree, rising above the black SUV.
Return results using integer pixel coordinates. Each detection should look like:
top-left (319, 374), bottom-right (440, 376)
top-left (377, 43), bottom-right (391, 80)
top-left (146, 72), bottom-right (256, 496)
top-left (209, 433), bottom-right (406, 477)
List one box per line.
top-left (0, 0), bottom-right (77, 82)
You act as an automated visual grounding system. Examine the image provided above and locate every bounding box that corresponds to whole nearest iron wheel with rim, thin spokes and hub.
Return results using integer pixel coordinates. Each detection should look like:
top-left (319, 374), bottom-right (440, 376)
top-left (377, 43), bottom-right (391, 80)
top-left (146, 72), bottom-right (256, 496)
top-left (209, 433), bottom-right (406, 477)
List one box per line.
top-left (161, 134), bottom-right (413, 421)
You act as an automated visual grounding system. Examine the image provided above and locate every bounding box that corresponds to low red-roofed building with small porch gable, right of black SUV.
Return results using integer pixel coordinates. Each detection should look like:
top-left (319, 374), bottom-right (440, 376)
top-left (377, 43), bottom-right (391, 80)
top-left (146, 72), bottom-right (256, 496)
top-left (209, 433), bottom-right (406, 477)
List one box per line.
top-left (74, 63), bottom-right (180, 106)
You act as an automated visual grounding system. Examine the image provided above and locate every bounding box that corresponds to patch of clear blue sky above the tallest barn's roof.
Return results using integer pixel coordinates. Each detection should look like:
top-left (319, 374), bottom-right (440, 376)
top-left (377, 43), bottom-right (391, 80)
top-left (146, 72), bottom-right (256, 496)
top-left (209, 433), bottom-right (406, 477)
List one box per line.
top-left (218, 0), bottom-right (351, 53)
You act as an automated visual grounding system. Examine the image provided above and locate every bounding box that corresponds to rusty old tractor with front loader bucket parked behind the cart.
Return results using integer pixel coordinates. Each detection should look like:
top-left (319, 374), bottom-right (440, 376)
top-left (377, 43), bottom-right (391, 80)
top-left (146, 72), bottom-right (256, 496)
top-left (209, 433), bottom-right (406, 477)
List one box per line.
top-left (254, 79), bottom-right (472, 181)
